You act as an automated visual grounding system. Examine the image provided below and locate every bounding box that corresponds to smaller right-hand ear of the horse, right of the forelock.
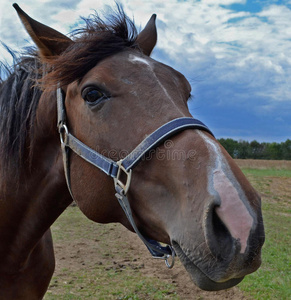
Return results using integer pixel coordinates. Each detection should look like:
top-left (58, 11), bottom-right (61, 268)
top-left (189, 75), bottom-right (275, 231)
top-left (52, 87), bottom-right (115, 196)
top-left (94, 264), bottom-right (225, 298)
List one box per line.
top-left (136, 14), bottom-right (157, 56)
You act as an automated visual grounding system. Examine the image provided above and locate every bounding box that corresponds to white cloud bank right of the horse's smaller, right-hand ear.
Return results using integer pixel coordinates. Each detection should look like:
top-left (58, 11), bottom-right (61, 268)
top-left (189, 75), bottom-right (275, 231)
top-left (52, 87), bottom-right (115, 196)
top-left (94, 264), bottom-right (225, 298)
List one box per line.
top-left (127, 1), bottom-right (291, 105)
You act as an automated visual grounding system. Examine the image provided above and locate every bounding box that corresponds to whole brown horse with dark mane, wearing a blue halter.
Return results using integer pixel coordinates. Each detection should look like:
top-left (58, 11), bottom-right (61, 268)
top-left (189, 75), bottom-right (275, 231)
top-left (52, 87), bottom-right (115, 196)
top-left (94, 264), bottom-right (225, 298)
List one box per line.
top-left (0, 4), bottom-right (264, 300)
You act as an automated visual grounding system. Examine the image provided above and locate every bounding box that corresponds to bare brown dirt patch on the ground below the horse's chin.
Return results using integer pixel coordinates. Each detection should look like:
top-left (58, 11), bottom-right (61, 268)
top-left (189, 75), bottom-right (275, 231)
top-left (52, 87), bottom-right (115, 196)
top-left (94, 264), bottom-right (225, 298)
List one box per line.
top-left (49, 221), bottom-right (249, 300)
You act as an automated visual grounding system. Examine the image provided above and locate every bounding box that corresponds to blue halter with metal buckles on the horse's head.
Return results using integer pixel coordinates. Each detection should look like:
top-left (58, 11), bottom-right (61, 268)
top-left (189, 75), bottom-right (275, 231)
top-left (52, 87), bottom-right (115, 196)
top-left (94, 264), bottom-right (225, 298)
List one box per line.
top-left (57, 88), bottom-right (213, 268)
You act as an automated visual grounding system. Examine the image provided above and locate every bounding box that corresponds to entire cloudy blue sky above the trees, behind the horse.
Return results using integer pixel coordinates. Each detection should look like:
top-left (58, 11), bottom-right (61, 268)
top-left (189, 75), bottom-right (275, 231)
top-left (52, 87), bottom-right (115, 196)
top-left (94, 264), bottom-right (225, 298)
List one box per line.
top-left (0, 0), bottom-right (291, 143)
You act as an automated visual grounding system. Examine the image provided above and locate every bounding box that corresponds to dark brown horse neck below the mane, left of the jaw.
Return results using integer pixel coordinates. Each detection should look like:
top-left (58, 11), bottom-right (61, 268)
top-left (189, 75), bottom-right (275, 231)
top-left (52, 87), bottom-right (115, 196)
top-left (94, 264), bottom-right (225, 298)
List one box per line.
top-left (0, 95), bottom-right (72, 271)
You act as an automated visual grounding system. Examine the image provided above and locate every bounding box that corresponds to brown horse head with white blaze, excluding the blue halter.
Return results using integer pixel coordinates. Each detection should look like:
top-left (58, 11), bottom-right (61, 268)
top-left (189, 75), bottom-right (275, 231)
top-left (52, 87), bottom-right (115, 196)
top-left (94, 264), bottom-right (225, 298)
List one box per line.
top-left (15, 5), bottom-right (264, 290)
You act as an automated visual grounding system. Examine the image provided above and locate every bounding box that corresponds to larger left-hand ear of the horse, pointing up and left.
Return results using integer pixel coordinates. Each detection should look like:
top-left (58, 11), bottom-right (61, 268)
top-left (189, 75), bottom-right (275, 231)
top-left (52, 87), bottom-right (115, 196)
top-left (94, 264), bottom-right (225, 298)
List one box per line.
top-left (13, 3), bottom-right (73, 58)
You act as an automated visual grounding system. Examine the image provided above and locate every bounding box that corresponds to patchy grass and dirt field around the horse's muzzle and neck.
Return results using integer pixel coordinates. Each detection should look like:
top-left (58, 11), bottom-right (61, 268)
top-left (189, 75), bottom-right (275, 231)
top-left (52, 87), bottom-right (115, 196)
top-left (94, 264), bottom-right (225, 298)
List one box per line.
top-left (45, 160), bottom-right (291, 300)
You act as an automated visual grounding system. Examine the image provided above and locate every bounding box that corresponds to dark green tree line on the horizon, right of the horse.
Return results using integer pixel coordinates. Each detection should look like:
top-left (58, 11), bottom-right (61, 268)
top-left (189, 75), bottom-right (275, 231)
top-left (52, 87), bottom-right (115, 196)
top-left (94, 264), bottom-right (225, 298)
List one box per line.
top-left (218, 138), bottom-right (291, 160)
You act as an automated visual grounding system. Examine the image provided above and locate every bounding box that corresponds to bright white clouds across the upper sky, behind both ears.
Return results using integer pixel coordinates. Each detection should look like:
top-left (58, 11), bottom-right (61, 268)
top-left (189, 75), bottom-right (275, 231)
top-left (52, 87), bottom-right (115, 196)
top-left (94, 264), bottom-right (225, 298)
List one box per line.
top-left (0, 0), bottom-right (291, 102)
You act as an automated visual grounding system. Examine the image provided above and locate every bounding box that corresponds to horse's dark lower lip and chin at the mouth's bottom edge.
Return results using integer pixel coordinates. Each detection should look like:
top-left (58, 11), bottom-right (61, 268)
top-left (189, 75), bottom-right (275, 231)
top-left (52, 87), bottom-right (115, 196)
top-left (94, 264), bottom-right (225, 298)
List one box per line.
top-left (172, 241), bottom-right (244, 291)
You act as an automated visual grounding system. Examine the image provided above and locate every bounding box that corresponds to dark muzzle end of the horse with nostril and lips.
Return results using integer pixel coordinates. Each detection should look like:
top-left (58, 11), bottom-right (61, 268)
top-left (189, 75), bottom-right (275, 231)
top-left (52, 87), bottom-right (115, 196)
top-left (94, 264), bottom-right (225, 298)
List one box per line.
top-left (172, 192), bottom-right (264, 291)
